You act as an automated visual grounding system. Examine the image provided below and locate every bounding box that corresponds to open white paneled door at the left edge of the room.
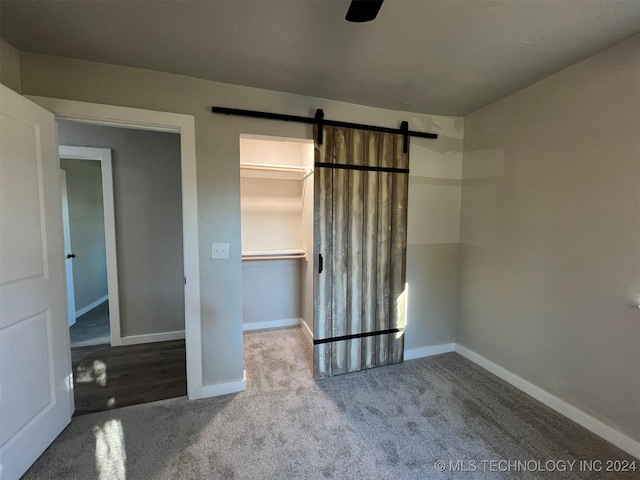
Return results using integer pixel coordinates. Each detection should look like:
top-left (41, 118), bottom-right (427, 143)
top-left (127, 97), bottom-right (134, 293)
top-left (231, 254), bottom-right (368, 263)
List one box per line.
top-left (0, 85), bottom-right (73, 479)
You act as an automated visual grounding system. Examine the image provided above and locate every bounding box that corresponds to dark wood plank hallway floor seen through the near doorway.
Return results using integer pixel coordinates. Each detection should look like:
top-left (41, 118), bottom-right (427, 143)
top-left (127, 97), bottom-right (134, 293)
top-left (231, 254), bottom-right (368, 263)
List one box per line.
top-left (71, 340), bottom-right (187, 415)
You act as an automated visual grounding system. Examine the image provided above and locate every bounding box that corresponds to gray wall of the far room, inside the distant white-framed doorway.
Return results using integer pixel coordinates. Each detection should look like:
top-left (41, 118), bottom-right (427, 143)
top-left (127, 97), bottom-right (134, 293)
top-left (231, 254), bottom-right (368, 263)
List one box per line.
top-left (60, 158), bottom-right (108, 312)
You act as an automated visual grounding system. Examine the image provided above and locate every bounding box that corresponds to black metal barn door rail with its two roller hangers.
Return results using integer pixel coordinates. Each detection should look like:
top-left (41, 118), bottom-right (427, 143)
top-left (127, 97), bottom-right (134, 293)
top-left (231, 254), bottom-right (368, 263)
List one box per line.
top-left (211, 107), bottom-right (438, 153)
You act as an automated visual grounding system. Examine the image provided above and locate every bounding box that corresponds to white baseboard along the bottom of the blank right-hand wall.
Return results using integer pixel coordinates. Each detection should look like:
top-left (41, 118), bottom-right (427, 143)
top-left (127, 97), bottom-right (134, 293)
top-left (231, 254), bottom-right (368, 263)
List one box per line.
top-left (456, 344), bottom-right (640, 458)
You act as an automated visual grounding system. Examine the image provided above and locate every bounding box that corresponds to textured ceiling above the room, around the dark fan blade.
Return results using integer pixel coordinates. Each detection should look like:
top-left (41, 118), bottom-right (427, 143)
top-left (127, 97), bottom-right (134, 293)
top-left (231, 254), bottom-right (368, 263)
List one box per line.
top-left (0, 0), bottom-right (640, 115)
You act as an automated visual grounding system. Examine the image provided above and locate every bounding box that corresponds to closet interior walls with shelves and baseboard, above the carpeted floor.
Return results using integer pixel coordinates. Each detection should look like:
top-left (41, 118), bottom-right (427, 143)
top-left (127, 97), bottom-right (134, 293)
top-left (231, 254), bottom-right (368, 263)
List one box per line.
top-left (240, 136), bottom-right (313, 335)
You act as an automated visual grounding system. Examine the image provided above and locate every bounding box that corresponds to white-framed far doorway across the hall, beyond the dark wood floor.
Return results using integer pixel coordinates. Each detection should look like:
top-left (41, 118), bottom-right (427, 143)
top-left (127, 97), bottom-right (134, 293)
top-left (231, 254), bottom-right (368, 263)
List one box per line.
top-left (59, 145), bottom-right (114, 347)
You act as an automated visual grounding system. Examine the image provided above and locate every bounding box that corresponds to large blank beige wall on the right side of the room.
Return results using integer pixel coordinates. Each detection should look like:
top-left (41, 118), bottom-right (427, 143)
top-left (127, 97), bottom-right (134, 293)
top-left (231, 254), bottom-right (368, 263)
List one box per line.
top-left (457, 37), bottom-right (640, 441)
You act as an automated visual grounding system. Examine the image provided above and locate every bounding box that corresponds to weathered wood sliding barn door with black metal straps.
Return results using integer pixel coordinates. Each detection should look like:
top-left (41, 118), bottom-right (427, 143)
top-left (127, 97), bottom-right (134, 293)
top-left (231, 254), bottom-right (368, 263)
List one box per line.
top-left (314, 126), bottom-right (409, 378)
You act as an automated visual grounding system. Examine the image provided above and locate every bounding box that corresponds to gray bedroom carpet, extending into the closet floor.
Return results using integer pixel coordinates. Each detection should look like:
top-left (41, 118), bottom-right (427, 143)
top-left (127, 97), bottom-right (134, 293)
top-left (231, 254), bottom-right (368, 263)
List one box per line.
top-left (24, 328), bottom-right (638, 480)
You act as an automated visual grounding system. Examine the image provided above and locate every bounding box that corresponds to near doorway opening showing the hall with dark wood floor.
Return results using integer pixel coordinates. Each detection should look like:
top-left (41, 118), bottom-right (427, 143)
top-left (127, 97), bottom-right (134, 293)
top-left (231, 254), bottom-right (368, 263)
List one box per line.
top-left (57, 120), bottom-right (187, 415)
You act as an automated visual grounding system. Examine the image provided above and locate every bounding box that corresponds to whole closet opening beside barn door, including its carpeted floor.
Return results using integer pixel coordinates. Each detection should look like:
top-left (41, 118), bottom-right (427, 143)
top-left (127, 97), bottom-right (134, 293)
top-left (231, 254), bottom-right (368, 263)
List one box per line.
top-left (239, 135), bottom-right (314, 382)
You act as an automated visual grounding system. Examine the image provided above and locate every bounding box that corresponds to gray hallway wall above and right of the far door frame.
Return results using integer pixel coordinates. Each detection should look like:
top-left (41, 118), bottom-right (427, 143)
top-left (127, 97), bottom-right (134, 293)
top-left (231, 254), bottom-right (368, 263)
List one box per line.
top-left (58, 122), bottom-right (184, 336)
